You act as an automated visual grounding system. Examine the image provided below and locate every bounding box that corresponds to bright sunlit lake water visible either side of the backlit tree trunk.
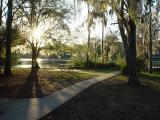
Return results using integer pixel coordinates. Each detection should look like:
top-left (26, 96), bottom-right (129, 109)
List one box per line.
top-left (15, 58), bottom-right (69, 68)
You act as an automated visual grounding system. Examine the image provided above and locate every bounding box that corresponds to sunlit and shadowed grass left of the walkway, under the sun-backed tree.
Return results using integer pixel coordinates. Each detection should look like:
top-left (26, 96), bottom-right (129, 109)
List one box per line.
top-left (0, 68), bottom-right (99, 98)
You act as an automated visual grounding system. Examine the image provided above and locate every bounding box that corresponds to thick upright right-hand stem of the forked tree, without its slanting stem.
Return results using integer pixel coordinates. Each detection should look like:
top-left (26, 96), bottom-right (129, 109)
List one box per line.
top-left (128, 19), bottom-right (140, 86)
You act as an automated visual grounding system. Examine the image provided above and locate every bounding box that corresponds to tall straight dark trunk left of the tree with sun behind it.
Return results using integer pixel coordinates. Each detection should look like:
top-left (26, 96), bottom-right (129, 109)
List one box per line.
top-left (4, 0), bottom-right (13, 77)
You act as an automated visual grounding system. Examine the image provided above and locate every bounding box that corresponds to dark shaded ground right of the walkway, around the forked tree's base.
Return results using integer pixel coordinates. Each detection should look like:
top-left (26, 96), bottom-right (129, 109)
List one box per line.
top-left (40, 75), bottom-right (160, 120)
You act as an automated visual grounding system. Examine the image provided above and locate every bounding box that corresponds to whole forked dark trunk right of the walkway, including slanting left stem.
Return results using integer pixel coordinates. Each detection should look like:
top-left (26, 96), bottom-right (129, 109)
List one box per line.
top-left (118, 19), bottom-right (140, 86)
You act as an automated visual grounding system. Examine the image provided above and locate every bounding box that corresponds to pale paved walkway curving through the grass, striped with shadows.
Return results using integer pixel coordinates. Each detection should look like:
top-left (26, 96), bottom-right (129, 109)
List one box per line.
top-left (0, 72), bottom-right (119, 120)
